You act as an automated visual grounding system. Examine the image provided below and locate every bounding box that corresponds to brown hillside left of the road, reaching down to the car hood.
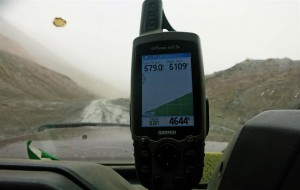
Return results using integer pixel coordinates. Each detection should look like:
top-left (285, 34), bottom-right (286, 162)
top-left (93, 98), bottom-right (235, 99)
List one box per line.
top-left (0, 35), bottom-right (96, 139)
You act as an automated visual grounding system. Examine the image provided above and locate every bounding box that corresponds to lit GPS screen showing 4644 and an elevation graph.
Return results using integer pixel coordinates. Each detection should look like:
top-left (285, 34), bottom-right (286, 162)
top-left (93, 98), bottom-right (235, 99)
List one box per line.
top-left (141, 53), bottom-right (194, 127)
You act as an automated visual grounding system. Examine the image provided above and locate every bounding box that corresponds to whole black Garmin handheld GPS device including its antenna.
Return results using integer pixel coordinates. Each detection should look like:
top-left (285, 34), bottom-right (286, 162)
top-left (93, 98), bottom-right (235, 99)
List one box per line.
top-left (130, 0), bottom-right (208, 189)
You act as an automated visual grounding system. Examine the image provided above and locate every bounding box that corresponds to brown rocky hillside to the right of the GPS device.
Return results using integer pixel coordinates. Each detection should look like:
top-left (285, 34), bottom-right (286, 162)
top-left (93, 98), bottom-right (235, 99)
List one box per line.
top-left (206, 58), bottom-right (300, 140)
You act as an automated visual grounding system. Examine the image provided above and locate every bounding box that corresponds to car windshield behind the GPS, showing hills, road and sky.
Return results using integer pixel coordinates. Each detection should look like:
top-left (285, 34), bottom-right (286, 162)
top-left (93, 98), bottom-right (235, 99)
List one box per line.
top-left (0, 0), bottom-right (300, 177)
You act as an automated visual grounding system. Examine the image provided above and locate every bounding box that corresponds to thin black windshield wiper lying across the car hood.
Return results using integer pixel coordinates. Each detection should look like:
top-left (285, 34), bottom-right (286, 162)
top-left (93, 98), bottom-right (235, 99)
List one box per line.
top-left (37, 122), bottom-right (129, 132)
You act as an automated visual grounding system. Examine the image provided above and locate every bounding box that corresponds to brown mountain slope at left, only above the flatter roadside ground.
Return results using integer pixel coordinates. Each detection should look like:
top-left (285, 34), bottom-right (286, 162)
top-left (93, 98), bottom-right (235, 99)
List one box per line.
top-left (0, 50), bottom-right (93, 100)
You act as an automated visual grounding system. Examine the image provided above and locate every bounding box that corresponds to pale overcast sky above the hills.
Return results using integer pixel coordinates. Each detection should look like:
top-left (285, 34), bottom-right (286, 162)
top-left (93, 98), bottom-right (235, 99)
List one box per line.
top-left (0, 0), bottom-right (300, 95)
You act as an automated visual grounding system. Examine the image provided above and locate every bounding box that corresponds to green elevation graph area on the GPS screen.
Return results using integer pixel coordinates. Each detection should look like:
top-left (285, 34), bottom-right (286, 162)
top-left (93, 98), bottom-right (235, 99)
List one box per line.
top-left (147, 93), bottom-right (194, 116)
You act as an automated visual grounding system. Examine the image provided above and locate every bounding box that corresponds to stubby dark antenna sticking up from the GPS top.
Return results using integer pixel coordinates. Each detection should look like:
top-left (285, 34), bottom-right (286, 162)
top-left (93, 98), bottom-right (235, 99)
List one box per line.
top-left (140, 0), bottom-right (175, 36)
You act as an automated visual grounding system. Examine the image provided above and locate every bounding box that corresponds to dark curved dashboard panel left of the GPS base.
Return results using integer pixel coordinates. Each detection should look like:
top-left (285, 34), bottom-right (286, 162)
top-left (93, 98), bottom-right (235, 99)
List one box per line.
top-left (0, 159), bottom-right (133, 190)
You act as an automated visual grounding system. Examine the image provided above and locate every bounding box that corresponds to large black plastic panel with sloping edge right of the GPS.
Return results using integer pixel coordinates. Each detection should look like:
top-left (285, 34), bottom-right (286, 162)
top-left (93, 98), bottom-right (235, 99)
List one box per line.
top-left (208, 110), bottom-right (300, 190)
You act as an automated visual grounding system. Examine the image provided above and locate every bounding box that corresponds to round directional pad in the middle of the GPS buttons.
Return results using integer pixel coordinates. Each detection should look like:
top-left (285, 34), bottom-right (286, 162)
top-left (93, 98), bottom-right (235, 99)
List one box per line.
top-left (155, 143), bottom-right (180, 169)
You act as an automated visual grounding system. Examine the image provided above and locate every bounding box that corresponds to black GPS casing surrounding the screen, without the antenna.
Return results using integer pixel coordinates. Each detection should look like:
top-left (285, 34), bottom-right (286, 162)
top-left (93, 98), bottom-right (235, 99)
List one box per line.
top-left (130, 32), bottom-right (208, 189)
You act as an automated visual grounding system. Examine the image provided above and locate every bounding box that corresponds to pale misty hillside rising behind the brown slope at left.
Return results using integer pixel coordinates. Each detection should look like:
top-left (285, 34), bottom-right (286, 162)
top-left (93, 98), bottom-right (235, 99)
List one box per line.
top-left (0, 18), bottom-right (124, 98)
